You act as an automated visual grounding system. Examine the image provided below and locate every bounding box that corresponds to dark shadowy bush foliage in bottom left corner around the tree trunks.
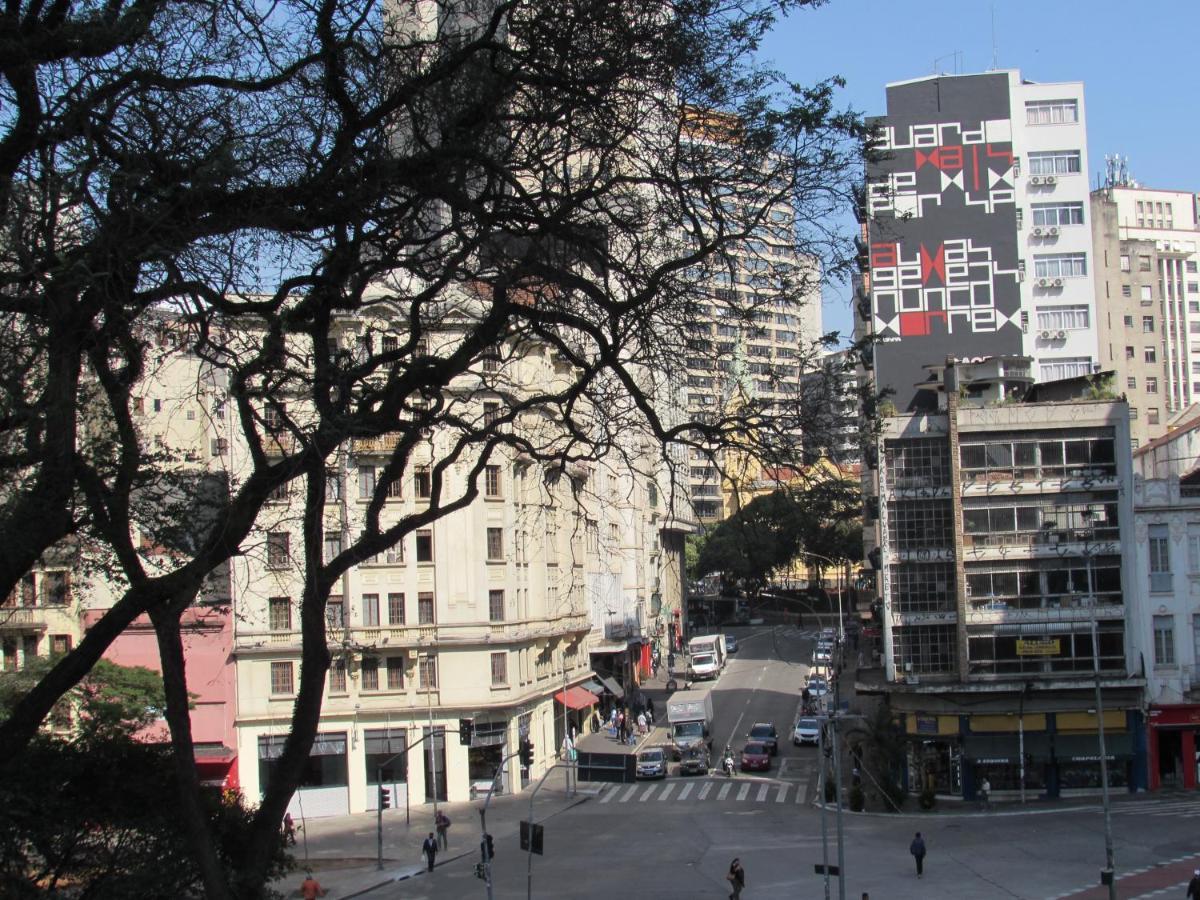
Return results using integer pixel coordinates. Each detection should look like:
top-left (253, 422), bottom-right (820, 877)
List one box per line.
top-left (0, 728), bottom-right (290, 900)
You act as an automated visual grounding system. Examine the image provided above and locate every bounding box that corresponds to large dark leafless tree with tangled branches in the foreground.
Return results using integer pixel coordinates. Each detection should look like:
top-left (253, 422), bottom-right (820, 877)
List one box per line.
top-left (0, 0), bottom-right (864, 896)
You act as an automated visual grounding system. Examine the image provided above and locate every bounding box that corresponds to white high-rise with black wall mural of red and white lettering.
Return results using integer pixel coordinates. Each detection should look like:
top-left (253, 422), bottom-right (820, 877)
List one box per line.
top-left (858, 70), bottom-right (1100, 410)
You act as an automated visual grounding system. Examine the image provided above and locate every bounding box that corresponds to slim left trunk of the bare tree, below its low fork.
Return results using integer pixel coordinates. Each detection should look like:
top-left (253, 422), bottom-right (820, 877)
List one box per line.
top-left (151, 600), bottom-right (233, 900)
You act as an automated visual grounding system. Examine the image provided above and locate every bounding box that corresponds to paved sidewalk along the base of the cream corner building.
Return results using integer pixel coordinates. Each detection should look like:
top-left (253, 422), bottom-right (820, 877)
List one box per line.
top-left (271, 770), bottom-right (589, 900)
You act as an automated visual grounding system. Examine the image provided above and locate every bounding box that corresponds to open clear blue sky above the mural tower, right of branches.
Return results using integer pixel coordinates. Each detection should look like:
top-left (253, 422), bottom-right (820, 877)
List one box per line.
top-left (761, 0), bottom-right (1200, 345)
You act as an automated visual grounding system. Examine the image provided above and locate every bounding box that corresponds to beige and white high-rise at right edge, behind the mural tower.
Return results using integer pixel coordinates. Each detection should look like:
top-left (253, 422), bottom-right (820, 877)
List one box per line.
top-left (1091, 178), bottom-right (1200, 448)
